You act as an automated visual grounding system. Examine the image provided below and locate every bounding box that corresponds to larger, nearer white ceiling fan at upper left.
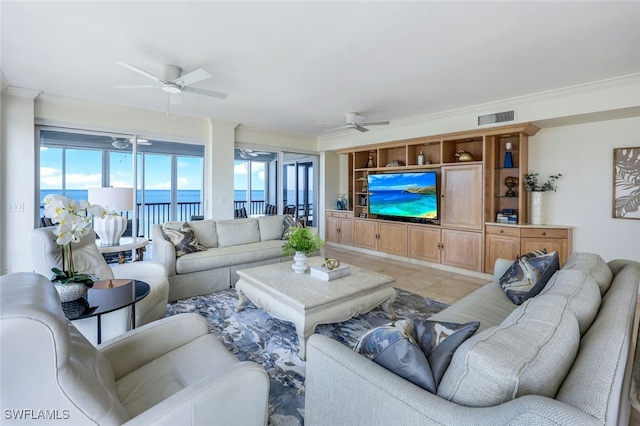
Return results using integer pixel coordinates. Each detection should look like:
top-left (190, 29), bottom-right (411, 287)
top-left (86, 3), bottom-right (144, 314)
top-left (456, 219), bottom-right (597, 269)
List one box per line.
top-left (113, 62), bottom-right (228, 104)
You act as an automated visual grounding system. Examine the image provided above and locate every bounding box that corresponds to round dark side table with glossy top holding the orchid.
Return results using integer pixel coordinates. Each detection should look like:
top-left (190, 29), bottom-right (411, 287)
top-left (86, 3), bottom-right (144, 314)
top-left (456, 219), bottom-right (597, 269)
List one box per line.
top-left (62, 279), bottom-right (150, 344)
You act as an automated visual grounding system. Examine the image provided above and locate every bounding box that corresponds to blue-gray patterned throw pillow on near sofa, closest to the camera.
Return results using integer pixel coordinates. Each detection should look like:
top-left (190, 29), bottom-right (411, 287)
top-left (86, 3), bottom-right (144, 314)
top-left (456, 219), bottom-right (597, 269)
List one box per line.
top-left (354, 320), bottom-right (480, 393)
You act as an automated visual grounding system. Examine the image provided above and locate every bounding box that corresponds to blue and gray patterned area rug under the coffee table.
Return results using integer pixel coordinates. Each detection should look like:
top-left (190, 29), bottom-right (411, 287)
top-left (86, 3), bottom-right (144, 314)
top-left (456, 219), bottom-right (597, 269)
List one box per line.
top-left (167, 289), bottom-right (448, 426)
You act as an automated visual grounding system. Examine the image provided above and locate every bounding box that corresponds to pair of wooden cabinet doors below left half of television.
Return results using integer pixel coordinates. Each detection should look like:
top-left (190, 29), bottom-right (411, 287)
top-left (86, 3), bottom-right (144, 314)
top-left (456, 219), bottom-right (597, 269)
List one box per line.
top-left (355, 219), bottom-right (407, 256)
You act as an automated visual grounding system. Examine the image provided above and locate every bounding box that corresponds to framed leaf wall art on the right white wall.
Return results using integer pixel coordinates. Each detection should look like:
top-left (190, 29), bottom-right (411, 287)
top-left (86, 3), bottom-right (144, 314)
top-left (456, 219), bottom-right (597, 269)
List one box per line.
top-left (613, 146), bottom-right (640, 219)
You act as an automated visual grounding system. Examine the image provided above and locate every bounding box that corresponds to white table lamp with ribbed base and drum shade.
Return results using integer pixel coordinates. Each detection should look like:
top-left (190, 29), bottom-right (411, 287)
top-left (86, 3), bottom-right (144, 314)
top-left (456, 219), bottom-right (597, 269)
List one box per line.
top-left (89, 187), bottom-right (133, 246)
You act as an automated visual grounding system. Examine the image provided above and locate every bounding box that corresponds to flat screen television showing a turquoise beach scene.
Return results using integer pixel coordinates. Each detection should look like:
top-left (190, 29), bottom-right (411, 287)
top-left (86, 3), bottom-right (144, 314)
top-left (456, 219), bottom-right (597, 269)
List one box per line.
top-left (367, 171), bottom-right (438, 221)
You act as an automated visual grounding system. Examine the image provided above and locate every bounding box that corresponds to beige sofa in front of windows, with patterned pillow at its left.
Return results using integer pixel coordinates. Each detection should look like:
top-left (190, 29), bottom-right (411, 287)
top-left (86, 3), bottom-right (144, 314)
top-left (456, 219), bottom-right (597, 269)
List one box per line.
top-left (152, 215), bottom-right (290, 302)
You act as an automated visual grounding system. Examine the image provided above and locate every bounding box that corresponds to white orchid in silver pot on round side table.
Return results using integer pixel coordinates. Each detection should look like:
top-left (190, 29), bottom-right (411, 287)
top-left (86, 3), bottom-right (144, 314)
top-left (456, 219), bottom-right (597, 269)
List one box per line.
top-left (43, 194), bottom-right (106, 302)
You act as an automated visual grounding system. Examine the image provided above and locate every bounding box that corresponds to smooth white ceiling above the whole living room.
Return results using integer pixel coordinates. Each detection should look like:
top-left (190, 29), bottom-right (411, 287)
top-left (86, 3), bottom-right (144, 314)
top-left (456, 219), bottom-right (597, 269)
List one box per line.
top-left (0, 0), bottom-right (640, 136)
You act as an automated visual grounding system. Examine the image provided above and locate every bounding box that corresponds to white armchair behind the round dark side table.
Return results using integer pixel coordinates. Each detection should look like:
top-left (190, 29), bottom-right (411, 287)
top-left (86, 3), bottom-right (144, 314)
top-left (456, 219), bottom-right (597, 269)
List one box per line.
top-left (28, 227), bottom-right (169, 338)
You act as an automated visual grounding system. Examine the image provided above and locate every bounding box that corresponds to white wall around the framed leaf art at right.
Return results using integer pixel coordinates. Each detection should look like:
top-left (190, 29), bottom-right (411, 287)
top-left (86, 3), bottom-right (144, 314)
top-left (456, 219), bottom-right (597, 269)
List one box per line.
top-left (529, 117), bottom-right (640, 261)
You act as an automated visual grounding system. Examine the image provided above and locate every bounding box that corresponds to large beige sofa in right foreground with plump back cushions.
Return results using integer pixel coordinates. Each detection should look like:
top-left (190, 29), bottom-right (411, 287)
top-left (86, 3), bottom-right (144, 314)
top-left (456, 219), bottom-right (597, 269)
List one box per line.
top-left (305, 253), bottom-right (640, 426)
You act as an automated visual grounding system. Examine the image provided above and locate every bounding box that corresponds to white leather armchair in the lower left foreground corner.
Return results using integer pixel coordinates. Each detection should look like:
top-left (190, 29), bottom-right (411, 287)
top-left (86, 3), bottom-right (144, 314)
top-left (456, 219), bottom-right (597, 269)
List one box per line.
top-left (0, 272), bottom-right (269, 425)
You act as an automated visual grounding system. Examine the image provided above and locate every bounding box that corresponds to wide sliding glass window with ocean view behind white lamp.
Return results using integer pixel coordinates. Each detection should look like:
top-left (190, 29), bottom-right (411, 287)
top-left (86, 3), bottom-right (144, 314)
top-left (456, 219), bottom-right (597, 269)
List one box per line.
top-left (39, 128), bottom-right (204, 237)
